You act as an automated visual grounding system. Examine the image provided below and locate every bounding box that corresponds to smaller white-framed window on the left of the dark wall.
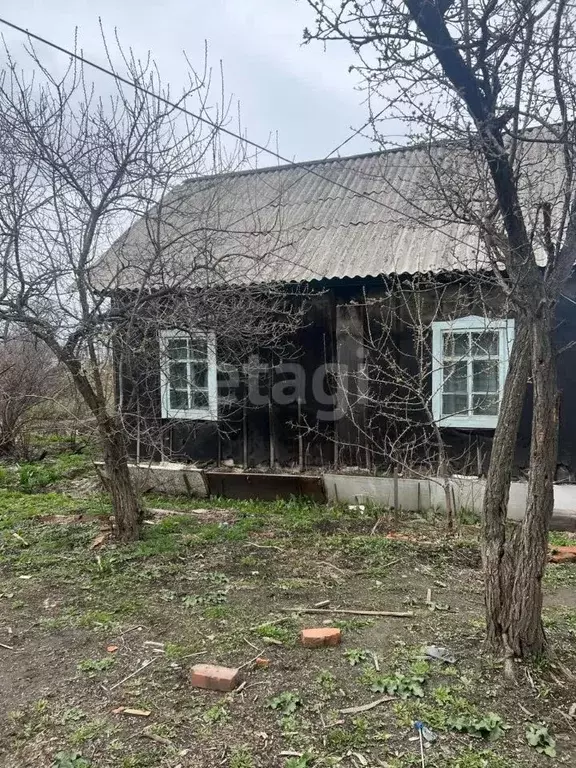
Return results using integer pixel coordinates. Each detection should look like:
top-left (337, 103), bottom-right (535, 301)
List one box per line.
top-left (160, 330), bottom-right (218, 421)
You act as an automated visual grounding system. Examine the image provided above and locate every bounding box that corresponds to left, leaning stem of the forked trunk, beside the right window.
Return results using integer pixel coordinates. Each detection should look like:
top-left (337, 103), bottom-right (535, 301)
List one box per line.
top-left (481, 319), bottom-right (531, 651)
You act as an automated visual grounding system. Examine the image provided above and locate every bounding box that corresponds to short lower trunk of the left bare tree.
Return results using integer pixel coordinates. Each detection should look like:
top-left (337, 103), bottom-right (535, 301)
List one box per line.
top-left (99, 419), bottom-right (143, 542)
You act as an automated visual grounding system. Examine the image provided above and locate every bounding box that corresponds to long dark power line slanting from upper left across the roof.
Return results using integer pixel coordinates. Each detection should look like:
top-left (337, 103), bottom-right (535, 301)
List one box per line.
top-left (0, 17), bottom-right (480, 260)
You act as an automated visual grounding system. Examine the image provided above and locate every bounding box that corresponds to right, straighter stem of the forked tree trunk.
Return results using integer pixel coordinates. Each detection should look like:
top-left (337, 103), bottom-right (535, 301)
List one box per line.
top-left (504, 310), bottom-right (558, 657)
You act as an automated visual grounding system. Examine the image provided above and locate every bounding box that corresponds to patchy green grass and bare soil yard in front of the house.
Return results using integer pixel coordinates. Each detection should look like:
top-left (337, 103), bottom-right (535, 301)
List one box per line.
top-left (0, 448), bottom-right (576, 768)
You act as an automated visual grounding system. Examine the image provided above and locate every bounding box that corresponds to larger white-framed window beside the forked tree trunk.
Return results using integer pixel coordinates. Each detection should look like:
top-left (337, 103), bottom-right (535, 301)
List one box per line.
top-left (432, 317), bottom-right (514, 429)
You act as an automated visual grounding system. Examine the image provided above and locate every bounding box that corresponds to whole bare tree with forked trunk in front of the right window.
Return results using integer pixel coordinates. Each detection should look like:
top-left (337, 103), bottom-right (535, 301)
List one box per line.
top-left (306, 0), bottom-right (576, 656)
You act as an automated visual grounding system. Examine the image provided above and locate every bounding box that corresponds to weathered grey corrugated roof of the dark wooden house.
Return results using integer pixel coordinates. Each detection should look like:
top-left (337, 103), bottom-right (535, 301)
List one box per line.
top-left (95, 130), bottom-right (564, 287)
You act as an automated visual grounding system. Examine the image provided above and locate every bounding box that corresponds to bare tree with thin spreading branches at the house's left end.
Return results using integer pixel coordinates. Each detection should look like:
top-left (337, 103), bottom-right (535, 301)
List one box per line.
top-left (0, 36), bottom-right (304, 541)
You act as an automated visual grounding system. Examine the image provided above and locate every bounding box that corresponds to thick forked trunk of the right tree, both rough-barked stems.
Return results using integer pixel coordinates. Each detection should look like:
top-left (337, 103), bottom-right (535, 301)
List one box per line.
top-left (482, 310), bottom-right (558, 657)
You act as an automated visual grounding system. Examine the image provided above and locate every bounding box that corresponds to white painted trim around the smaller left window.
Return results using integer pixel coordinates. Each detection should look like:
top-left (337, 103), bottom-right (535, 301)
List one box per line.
top-left (159, 329), bottom-right (218, 421)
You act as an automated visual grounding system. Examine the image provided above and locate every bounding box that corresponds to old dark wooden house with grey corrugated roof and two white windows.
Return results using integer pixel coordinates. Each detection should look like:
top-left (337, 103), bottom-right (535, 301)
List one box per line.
top-left (101, 135), bottom-right (576, 500)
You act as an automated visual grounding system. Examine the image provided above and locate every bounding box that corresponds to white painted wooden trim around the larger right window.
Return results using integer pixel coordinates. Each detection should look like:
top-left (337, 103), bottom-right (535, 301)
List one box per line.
top-left (432, 315), bottom-right (514, 429)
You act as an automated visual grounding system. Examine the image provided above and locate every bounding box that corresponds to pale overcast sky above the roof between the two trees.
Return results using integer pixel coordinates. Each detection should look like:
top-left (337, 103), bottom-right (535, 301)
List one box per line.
top-left (2, 0), bottom-right (375, 165)
